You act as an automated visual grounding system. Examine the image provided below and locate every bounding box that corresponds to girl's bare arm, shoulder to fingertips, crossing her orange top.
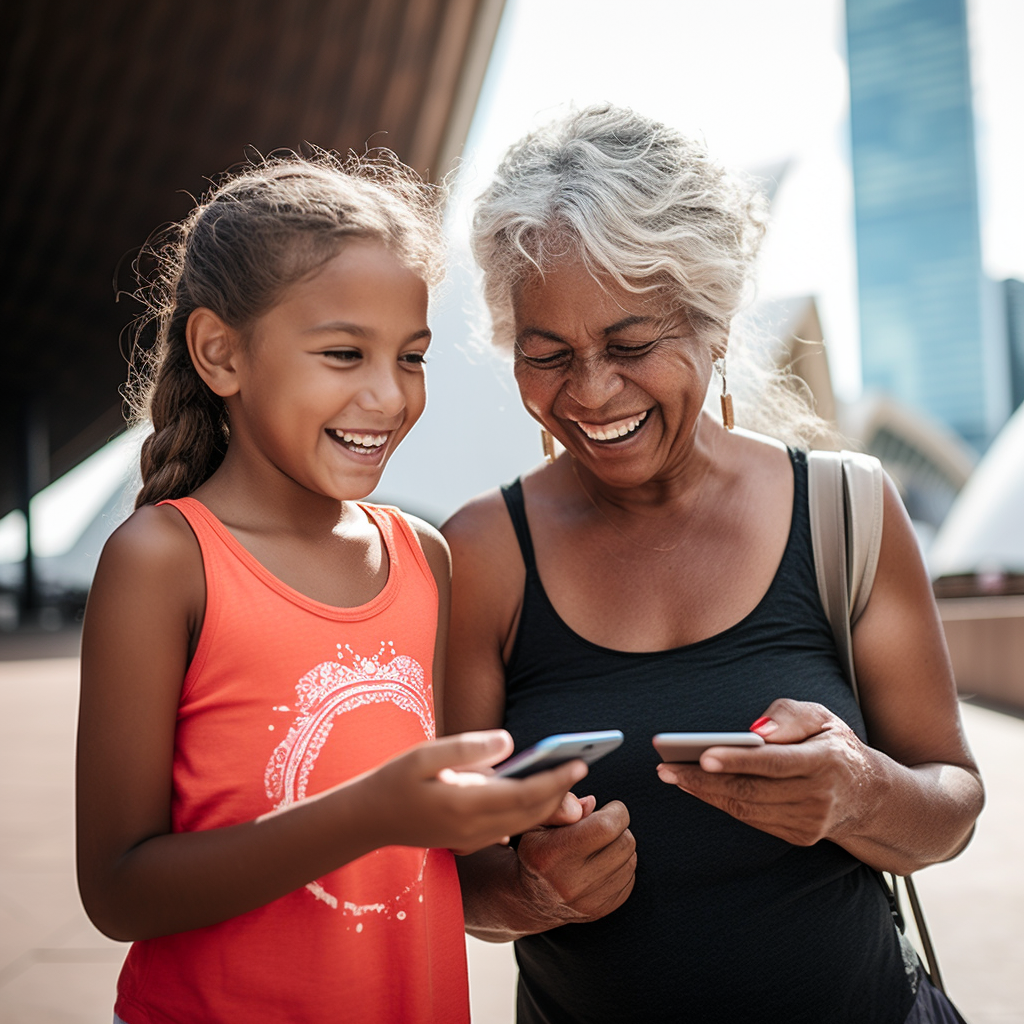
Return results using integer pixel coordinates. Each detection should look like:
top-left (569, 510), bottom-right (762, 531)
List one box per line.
top-left (77, 508), bottom-right (586, 939)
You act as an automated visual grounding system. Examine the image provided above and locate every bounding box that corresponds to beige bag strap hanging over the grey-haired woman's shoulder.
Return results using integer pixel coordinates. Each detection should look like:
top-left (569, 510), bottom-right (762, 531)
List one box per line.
top-left (807, 452), bottom-right (945, 992)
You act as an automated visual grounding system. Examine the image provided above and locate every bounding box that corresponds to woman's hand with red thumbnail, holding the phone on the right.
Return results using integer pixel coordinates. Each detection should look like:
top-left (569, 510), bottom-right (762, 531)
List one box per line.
top-left (657, 699), bottom-right (884, 846)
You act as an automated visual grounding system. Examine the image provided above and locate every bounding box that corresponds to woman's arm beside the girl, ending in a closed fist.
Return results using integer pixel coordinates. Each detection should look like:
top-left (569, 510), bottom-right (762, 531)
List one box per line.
top-left (441, 493), bottom-right (636, 942)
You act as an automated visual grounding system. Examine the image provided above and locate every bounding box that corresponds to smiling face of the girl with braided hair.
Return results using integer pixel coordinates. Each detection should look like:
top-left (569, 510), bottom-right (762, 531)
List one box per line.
top-left (228, 239), bottom-right (430, 500)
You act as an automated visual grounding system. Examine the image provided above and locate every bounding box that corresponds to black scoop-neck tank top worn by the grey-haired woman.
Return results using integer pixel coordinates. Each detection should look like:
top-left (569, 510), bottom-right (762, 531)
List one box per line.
top-left (503, 452), bottom-right (912, 1024)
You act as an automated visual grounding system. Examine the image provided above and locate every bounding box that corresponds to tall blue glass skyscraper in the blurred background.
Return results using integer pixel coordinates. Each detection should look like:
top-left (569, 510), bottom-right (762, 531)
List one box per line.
top-left (846, 0), bottom-right (1009, 447)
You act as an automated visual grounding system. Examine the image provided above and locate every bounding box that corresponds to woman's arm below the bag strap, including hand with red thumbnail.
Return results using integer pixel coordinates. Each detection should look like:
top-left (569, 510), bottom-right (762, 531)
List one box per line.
top-left (658, 479), bottom-right (984, 874)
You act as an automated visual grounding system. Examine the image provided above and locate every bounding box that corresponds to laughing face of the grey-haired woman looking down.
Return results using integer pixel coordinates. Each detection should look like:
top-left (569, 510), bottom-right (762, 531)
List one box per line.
top-left (512, 262), bottom-right (712, 486)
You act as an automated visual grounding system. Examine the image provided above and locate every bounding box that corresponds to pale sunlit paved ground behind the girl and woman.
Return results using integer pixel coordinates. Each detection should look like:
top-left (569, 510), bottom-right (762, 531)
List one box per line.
top-left (0, 636), bottom-right (1024, 1024)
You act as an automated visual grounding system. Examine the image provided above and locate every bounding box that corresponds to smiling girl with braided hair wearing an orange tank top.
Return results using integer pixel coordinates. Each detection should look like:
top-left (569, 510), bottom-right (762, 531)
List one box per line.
top-left (78, 154), bottom-right (586, 1024)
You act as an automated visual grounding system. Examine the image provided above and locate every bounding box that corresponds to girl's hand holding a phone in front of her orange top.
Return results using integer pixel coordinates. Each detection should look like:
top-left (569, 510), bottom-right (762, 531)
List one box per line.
top-left (364, 729), bottom-right (587, 854)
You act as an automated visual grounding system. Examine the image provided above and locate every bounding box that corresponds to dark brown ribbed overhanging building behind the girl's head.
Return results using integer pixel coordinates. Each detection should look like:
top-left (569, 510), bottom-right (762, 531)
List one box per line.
top-left (0, 0), bottom-right (503, 622)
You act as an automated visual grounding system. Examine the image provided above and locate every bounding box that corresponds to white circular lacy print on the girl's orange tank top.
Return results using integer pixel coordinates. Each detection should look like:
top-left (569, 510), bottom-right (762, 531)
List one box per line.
top-left (263, 640), bottom-right (435, 932)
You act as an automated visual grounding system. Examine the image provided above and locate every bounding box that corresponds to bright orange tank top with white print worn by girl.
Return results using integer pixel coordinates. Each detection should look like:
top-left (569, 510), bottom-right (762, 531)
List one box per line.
top-left (116, 498), bottom-right (469, 1024)
